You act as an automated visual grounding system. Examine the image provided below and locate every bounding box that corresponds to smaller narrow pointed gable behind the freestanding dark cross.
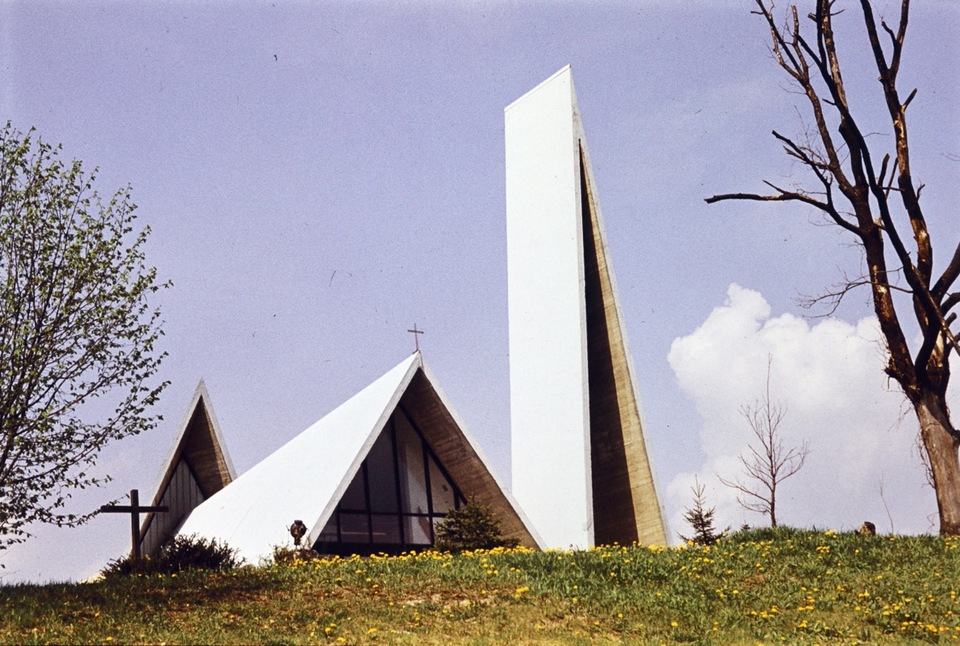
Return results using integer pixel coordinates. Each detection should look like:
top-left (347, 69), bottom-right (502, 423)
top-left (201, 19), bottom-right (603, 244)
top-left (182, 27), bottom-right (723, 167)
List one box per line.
top-left (140, 381), bottom-right (236, 554)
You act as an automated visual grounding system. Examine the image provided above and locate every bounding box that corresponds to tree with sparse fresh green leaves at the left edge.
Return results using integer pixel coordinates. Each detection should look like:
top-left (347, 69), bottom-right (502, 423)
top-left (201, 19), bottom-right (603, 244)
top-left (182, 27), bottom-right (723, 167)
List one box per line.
top-left (0, 123), bottom-right (168, 550)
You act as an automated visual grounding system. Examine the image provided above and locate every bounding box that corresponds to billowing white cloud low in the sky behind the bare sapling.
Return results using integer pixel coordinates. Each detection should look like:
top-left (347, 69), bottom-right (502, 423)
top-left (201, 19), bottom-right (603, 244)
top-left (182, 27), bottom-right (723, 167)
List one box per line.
top-left (667, 284), bottom-right (936, 533)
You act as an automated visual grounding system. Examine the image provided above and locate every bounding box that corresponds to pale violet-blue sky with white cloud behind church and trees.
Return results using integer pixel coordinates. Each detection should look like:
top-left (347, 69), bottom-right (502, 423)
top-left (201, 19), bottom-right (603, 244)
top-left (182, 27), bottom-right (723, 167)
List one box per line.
top-left (0, 0), bottom-right (960, 581)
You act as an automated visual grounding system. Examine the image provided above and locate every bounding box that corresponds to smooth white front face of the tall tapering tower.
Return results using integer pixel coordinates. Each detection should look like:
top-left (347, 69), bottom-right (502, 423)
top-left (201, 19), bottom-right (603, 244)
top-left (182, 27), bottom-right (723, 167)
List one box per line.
top-left (504, 66), bottom-right (593, 548)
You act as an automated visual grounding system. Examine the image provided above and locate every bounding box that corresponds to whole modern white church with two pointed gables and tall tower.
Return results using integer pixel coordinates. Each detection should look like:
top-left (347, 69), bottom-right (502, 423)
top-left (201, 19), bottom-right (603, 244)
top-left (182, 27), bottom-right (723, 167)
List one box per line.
top-left (140, 66), bottom-right (666, 563)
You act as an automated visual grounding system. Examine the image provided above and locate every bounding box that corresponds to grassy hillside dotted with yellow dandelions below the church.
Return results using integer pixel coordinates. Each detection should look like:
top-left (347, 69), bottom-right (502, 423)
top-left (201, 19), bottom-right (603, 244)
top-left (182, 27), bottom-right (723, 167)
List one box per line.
top-left (0, 529), bottom-right (960, 645)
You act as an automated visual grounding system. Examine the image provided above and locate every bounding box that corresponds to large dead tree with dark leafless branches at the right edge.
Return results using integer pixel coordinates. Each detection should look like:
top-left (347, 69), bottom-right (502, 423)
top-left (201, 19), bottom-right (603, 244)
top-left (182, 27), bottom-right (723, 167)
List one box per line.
top-left (706, 0), bottom-right (960, 535)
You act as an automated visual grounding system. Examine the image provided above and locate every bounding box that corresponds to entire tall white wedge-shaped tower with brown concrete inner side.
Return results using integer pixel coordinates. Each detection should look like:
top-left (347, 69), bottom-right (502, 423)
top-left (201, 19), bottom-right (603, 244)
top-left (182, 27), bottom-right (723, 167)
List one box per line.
top-left (504, 66), bottom-right (666, 548)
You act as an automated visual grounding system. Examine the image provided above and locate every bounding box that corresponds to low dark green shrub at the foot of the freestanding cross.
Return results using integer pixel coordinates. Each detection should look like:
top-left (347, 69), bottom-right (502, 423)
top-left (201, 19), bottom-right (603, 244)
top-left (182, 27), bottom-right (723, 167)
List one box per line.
top-left (102, 535), bottom-right (242, 577)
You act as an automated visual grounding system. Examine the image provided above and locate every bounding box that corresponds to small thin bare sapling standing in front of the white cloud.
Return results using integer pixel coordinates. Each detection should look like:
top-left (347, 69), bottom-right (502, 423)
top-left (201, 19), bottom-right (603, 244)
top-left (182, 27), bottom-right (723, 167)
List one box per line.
top-left (717, 360), bottom-right (810, 527)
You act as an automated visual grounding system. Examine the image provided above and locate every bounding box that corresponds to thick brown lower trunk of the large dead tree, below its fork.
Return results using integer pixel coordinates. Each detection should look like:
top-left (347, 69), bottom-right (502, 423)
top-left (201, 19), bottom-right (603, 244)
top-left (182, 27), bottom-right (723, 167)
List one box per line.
top-left (914, 391), bottom-right (960, 536)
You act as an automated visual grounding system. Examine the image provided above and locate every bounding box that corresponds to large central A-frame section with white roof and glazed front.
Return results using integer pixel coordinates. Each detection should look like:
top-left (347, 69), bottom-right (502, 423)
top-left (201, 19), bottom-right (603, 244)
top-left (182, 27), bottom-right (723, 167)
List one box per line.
top-left (180, 353), bottom-right (537, 563)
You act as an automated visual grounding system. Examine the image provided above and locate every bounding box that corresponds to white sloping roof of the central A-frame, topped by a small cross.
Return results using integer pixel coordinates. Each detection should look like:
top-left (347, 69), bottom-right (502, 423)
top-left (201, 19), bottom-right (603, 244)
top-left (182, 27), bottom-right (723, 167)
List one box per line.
top-left (179, 353), bottom-right (537, 564)
